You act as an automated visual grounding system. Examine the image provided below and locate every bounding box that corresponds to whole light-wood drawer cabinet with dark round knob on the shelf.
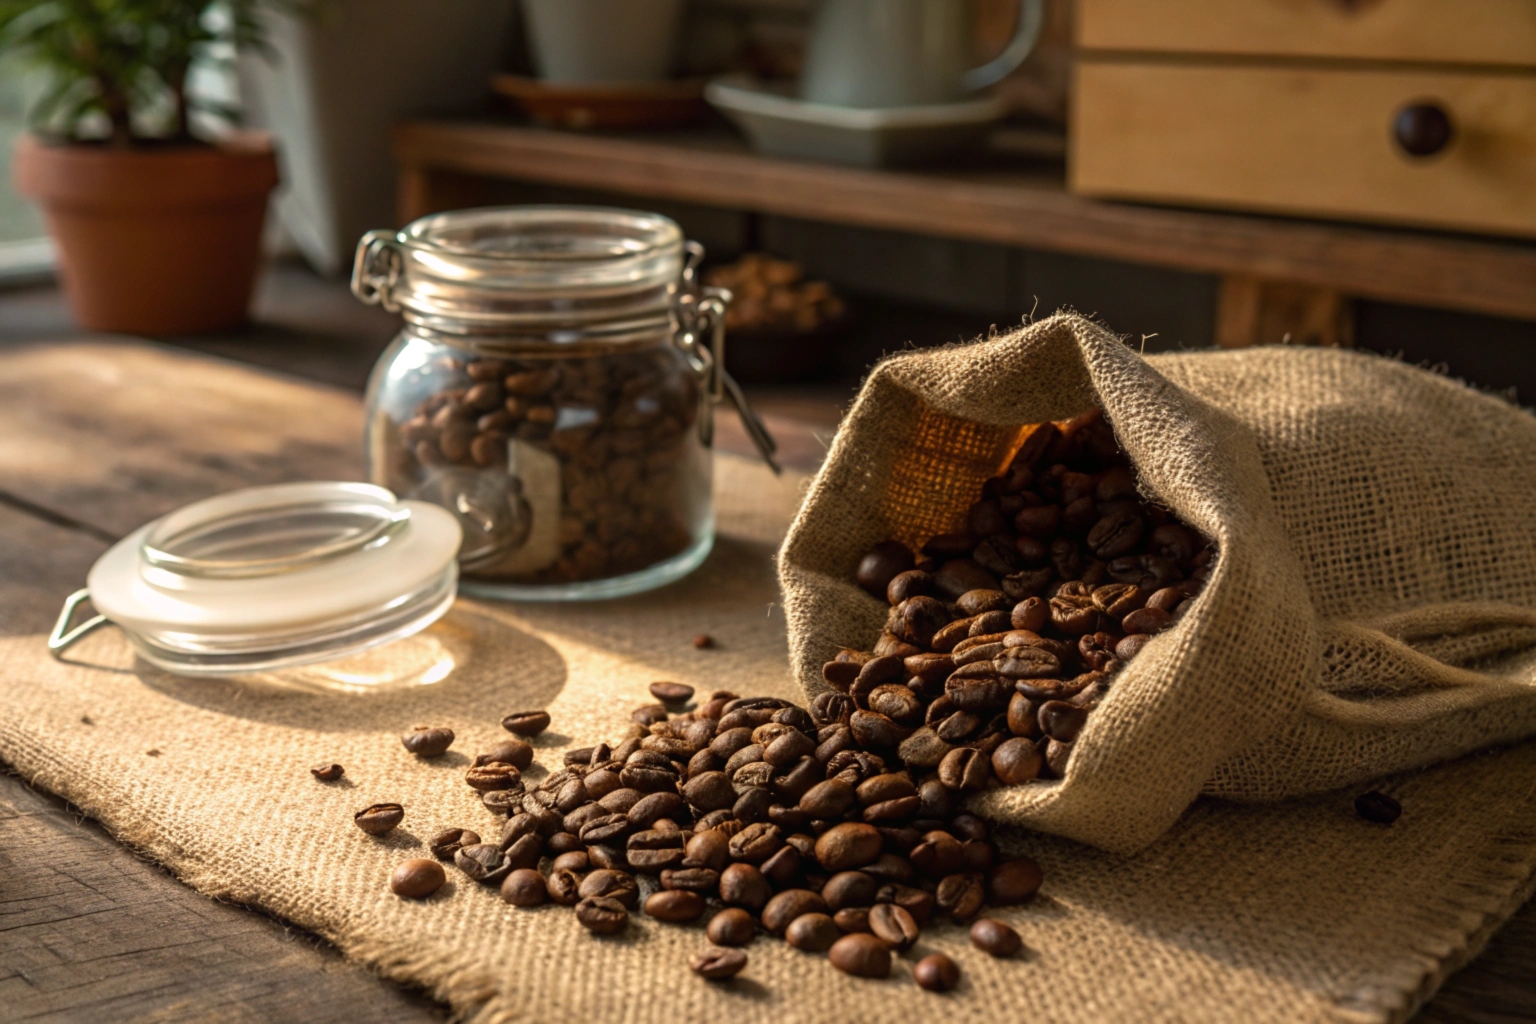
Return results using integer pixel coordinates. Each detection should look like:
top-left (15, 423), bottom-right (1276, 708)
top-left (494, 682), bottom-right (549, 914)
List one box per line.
top-left (1068, 0), bottom-right (1536, 236)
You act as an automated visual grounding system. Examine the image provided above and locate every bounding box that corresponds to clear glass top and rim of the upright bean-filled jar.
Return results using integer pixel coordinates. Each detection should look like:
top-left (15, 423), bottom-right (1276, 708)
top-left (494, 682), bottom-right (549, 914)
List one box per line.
top-left (352, 206), bottom-right (688, 341)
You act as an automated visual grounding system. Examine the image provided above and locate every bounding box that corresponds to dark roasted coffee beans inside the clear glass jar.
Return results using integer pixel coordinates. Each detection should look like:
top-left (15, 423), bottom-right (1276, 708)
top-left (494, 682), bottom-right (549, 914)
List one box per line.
top-left (387, 345), bottom-right (702, 583)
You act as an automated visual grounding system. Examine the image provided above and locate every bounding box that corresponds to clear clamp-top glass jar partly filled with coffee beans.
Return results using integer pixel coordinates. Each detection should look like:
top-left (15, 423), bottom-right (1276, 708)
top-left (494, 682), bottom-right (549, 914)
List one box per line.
top-left (352, 206), bottom-right (773, 600)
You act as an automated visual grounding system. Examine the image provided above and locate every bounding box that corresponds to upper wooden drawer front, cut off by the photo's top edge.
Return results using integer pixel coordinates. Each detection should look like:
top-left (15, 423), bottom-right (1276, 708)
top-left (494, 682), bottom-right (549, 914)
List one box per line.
top-left (1077, 0), bottom-right (1536, 66)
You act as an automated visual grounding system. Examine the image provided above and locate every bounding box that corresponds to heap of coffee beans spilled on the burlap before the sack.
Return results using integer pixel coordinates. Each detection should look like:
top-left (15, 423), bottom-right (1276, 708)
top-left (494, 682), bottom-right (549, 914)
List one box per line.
top-left (356, 683), bottom-right (1041, 992)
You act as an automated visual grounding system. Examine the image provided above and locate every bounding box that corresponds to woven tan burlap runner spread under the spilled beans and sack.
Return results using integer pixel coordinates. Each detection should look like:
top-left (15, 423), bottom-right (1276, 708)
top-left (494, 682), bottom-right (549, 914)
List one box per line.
top-left (0, 457), bottom-right (1536, 1024)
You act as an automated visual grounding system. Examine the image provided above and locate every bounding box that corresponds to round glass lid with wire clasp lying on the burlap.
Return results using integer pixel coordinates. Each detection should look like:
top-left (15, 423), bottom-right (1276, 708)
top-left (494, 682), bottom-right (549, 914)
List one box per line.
top-left (49, 482), bottom-right (459, 676)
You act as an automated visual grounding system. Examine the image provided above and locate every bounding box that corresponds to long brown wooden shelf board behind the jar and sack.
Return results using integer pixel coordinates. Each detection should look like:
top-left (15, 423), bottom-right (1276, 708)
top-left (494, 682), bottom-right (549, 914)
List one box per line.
top-left (395, 120), bottom-right (1536, 328)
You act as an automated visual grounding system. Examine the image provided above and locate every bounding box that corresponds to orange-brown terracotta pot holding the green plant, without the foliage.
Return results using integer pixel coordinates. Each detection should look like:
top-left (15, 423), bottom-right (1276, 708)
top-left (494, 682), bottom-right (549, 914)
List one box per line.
top-left (15, 137), bottom-right (278, 335)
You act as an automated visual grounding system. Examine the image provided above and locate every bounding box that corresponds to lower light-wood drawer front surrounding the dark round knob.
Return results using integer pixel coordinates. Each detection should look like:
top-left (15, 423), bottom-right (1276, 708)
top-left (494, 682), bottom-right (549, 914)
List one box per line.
top-left (1069, 62), bottom-right (1536, 235)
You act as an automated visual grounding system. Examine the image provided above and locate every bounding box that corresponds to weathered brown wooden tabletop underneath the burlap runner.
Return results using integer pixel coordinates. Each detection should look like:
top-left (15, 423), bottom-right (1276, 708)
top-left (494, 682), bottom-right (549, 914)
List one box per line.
top-left (0, 344), bottom-right (1536, 1024)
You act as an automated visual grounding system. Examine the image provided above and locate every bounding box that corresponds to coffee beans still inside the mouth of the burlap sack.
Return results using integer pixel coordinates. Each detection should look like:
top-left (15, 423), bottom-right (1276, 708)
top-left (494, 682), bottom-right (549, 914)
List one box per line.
top-left (835, 411), bottom-right (1215, 792)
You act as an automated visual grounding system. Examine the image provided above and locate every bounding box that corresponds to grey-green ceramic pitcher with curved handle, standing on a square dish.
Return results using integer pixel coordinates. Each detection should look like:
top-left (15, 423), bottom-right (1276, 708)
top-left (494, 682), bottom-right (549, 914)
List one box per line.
top-left (800, 0), bottom-right (1044, 107)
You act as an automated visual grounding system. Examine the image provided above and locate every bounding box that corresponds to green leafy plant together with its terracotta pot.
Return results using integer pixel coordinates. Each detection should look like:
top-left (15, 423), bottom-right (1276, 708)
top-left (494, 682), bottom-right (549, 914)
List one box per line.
top-left (0, 0), bottom-right (300, 335)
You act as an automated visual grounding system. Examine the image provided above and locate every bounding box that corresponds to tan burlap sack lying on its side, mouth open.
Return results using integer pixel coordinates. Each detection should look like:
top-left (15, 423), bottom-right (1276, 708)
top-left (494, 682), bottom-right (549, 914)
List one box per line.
top-left (780, 315), bottom-right (1536, 852)
